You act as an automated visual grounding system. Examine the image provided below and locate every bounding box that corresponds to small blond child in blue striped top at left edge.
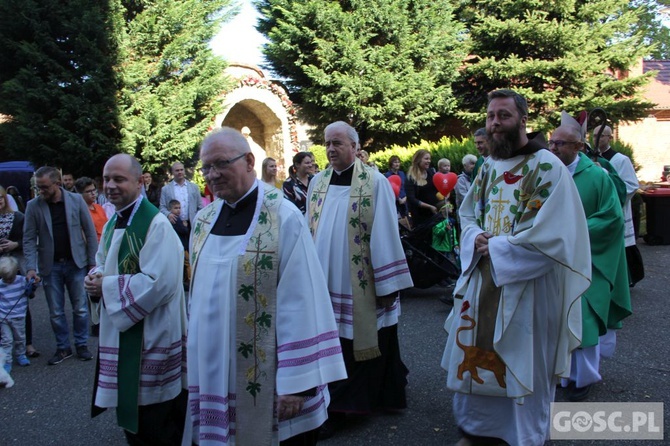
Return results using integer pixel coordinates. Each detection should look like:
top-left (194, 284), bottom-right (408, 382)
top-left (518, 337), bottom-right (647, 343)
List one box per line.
top-left (0, 256), bottom-right (30, 373)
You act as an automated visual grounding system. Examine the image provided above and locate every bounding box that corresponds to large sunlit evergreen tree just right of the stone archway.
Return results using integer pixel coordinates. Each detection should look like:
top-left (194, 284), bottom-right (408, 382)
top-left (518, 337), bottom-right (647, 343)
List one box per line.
top-left (256, 0), bottom-right (463, 148)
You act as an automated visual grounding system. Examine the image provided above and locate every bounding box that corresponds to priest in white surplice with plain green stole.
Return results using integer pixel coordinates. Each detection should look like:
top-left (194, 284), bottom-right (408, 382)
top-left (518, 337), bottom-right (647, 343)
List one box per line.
top-left (84, 154), bottom-right (186, 445)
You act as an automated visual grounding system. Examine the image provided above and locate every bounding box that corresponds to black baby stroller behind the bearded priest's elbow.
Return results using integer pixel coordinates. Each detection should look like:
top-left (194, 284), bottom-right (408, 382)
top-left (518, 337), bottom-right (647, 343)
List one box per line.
top-left (400, 213), bottom-right (460, 289)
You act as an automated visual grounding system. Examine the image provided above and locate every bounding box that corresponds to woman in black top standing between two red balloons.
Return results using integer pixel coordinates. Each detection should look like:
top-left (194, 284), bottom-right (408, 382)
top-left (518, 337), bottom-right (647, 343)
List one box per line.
top-left (406, 149), bottom-right (444, 226)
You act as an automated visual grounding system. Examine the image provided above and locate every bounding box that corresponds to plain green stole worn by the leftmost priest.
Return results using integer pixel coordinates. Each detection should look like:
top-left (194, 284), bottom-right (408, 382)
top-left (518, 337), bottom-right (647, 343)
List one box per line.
top-left (102, 198), bottom-right (159, 433)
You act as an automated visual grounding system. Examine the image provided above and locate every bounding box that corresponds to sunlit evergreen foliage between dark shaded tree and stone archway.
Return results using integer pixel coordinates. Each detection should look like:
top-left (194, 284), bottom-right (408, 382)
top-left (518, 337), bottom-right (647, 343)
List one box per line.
top-left (119, 0), bottom-right (234, 171)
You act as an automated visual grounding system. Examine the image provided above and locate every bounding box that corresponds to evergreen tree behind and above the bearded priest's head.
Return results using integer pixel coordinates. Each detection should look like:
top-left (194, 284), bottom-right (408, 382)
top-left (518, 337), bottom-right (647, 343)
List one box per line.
top-left (455, 0), bottom-right (651, 130)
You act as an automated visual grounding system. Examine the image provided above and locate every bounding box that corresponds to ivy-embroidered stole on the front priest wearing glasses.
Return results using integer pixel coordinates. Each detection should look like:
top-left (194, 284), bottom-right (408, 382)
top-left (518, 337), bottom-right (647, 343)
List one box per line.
top-left (190, 181), bottom-right (284, 445)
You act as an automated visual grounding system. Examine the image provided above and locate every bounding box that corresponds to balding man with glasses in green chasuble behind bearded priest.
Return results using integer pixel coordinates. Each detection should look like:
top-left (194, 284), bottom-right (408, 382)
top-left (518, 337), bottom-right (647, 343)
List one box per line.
top-left (549, 124), bottom-right (631, 401)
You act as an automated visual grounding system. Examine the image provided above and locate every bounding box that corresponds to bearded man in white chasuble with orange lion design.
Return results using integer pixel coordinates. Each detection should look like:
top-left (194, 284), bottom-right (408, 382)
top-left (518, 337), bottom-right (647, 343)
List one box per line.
top-left (442, 90), bottom-right (591, 446)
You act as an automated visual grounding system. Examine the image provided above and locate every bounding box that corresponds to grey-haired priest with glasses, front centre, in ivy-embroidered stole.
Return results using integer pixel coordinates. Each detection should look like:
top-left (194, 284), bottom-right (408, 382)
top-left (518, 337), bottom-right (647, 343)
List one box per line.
top-left (183, 127), bottom-right (346, 446)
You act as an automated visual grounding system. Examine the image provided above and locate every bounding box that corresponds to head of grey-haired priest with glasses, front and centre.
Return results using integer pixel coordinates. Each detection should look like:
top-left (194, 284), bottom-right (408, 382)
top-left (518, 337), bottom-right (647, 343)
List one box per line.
top-left (200, 127), bottom-right (256, 203)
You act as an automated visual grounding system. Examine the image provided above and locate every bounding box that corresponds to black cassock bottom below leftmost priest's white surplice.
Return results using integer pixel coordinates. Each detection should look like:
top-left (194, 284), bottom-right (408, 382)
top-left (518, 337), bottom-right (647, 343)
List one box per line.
top-left (124, 390), bottom-right (188, 446)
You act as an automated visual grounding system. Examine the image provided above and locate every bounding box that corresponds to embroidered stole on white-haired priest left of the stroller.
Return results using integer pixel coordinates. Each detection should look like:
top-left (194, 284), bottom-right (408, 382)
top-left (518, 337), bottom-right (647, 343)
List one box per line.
top-left (308, 159), bottom-right (381, 361)
